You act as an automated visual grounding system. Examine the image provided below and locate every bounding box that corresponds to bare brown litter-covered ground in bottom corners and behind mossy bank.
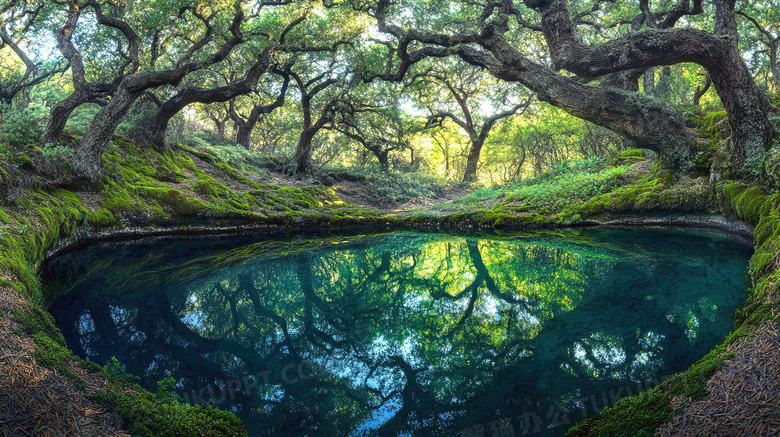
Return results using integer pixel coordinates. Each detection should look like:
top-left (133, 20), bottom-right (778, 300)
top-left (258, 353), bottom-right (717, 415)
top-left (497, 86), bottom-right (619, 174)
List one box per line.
top-left (0, 148), bottom-right (780, 437)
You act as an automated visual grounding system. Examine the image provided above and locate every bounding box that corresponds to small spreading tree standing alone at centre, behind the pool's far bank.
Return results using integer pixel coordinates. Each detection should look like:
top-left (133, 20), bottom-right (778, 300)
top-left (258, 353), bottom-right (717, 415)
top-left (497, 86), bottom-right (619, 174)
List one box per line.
top-left (410, 64), bottom-right (530, 182)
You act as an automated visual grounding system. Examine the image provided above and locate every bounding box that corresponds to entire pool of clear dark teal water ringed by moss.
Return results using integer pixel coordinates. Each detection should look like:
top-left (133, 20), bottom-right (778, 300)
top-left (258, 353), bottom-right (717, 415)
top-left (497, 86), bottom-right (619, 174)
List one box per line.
top-left (44, 229), bottom-right (751, 436)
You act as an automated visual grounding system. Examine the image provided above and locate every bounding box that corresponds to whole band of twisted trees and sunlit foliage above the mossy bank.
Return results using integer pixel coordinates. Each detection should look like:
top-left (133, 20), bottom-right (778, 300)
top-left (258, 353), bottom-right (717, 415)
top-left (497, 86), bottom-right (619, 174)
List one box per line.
top-left (0, 0), bottom-right (780, 181)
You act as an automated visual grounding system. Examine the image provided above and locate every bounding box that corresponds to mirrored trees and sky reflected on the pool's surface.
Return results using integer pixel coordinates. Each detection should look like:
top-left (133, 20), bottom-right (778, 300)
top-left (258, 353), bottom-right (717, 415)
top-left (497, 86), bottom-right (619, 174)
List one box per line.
top-left (47, 230), bottom-right (741, 435)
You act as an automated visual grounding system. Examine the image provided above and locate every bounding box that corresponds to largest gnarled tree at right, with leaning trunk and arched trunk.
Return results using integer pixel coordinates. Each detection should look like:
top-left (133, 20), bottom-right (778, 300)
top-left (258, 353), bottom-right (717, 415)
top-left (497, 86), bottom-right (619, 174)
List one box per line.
top-left (372, 0), bottom-right (774, 171)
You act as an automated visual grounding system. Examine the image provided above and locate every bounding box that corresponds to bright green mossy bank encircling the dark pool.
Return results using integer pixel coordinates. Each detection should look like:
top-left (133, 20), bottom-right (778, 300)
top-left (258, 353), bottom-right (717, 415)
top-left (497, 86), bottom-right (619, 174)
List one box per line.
top-left (0, 142), bottom-right (780, 436)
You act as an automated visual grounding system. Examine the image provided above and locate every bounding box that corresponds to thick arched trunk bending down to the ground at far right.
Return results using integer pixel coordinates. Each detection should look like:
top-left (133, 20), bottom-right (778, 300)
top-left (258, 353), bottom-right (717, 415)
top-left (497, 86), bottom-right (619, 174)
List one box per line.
top-left (525, 0), bottom-right (774, 170)
